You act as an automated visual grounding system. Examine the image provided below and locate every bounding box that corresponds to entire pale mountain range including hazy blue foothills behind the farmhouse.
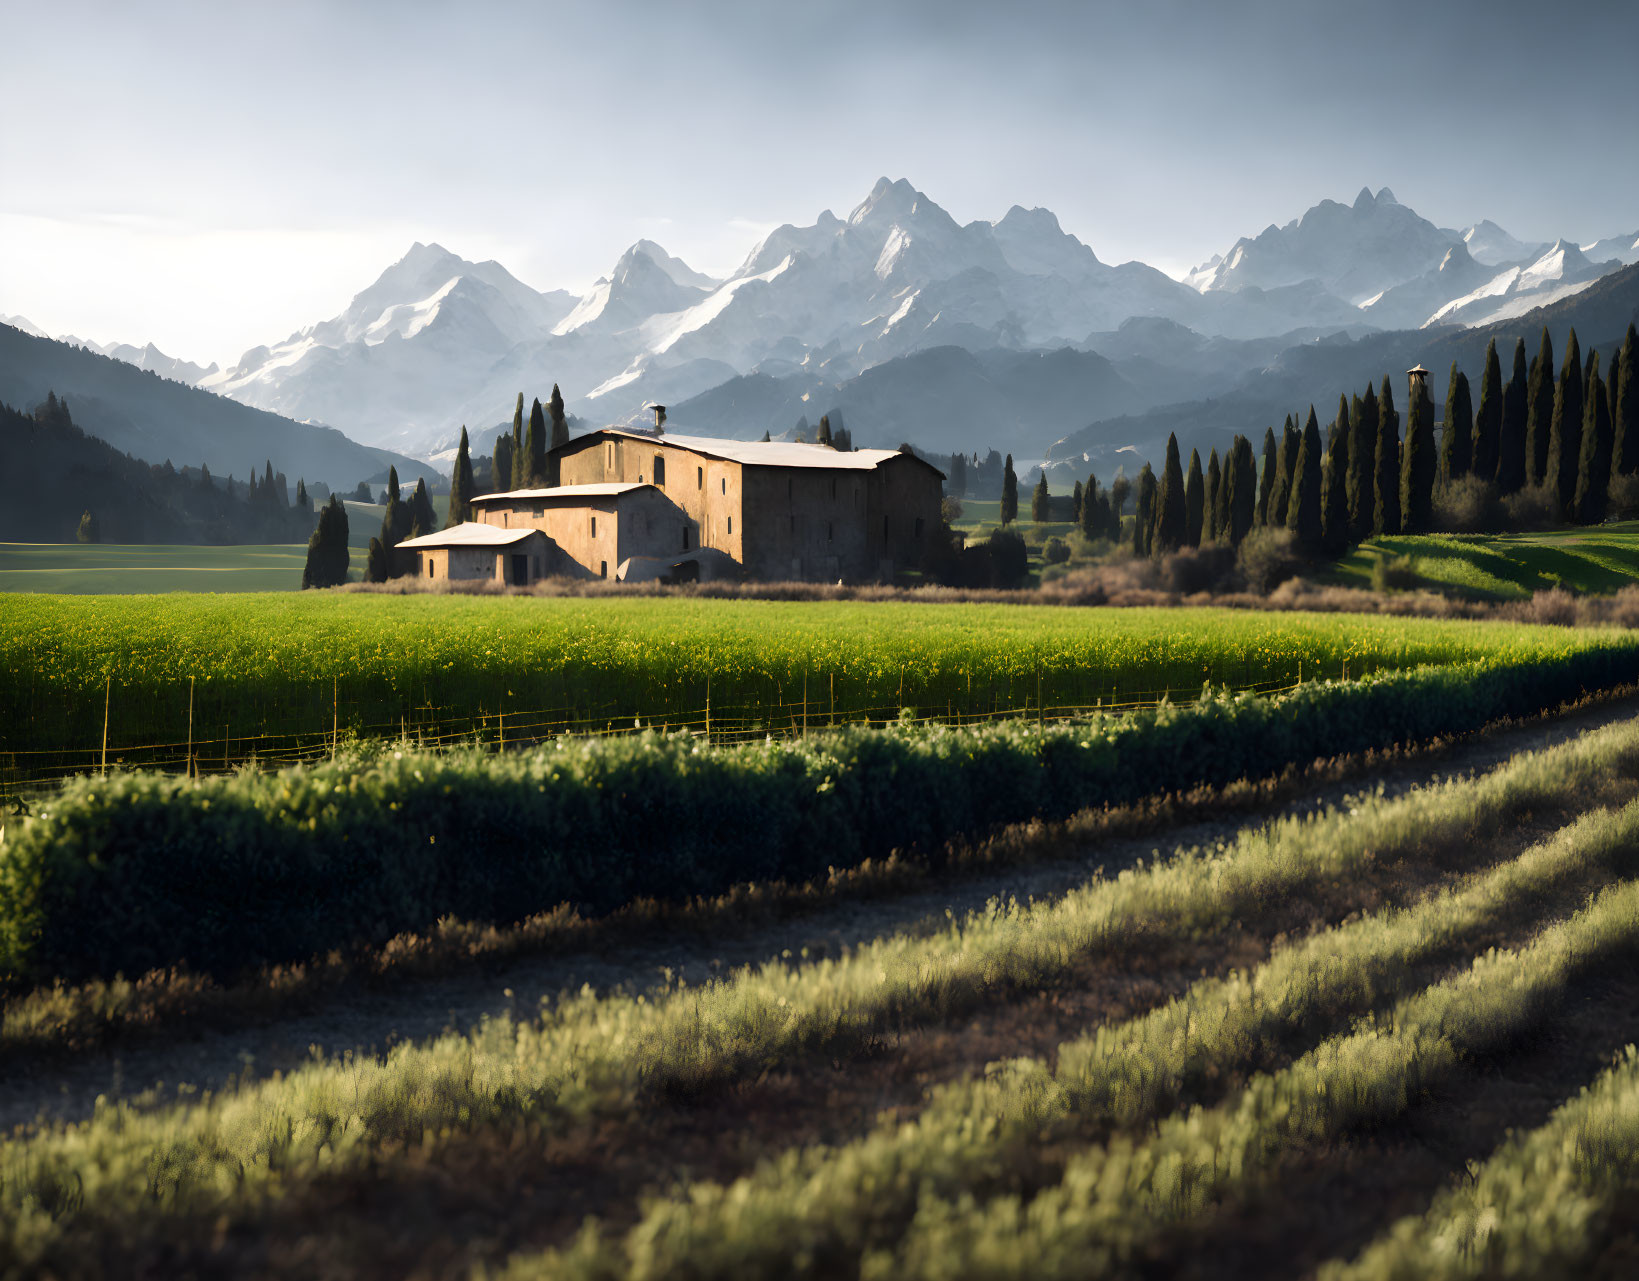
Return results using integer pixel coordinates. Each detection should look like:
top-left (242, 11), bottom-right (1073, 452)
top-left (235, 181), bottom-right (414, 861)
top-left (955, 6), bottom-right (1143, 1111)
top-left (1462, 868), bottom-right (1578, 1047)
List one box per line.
top-left (12, 179), bottom-right (1639, 455)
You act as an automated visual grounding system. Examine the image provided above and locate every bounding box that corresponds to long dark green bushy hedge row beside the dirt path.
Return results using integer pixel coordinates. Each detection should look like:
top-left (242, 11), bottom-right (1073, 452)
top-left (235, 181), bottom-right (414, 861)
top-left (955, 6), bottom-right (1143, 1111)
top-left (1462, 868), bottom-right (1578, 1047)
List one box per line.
top-left (0, 649), bottom-right (1639, 986)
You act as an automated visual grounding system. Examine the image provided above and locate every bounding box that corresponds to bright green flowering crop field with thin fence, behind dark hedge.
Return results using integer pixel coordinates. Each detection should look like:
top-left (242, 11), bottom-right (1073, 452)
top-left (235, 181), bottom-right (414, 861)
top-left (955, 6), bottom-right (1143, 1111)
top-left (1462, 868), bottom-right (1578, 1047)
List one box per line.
top-left (0, 593), bottom-right (1639, 767)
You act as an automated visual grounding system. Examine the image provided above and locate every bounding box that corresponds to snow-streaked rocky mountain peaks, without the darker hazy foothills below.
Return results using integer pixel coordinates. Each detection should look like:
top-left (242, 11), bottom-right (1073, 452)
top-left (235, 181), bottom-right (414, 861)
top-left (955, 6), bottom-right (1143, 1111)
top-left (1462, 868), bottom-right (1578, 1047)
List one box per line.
top-left (191, 179), bottom-right (1639, 455)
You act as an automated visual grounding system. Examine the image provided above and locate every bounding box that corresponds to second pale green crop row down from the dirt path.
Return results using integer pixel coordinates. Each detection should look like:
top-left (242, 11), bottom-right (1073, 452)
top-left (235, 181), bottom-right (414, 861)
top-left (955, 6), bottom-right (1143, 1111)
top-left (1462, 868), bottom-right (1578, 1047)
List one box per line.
top-left (501, 804), bottom-right (1639, 1276)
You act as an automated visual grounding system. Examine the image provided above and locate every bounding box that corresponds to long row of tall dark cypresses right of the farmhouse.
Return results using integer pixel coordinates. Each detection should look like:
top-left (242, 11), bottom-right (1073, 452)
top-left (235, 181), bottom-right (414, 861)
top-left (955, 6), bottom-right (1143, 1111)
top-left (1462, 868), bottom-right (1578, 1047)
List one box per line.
top-left (1127, 324), bottom-right (1639, 557)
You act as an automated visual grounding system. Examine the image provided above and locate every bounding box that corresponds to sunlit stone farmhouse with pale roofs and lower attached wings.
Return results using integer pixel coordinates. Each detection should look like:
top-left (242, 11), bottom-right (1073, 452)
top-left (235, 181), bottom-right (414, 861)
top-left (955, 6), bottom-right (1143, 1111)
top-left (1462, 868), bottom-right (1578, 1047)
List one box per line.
top-left (397, 428), bottom-right (944, 585)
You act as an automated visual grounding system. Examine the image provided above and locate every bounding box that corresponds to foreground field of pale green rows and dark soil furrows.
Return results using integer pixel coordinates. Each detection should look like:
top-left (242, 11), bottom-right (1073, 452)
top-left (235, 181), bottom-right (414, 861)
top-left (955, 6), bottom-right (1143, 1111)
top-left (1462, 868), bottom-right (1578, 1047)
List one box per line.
top-left (9, 707), bottom-right (1639, 1281)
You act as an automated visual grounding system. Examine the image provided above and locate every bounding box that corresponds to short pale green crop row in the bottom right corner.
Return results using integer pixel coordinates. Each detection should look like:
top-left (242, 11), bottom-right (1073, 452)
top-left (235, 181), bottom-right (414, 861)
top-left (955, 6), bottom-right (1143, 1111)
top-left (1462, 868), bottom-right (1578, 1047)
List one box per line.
top-left (1319, 1045), bottom-right (1639, 1281)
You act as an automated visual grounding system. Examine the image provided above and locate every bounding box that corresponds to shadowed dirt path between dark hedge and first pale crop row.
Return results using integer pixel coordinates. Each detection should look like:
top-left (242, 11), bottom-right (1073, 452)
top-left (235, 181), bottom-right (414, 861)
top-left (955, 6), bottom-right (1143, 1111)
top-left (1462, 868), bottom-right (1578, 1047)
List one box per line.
top-left (0, 696), bottom-right (1639, 1134)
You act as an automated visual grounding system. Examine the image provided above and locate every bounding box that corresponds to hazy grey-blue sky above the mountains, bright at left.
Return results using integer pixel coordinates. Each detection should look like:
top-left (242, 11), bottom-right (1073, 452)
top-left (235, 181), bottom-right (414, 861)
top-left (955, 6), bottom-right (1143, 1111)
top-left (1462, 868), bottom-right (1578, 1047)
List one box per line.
top-left (0, 0), bottom-right (1639, 364)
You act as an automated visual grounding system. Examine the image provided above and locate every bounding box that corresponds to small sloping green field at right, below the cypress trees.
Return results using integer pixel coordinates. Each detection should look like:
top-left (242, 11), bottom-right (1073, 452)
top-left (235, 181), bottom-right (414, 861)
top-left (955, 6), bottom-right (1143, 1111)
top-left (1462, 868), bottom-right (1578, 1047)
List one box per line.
top-left (1333, 521), bottom-right (1639, 600)
